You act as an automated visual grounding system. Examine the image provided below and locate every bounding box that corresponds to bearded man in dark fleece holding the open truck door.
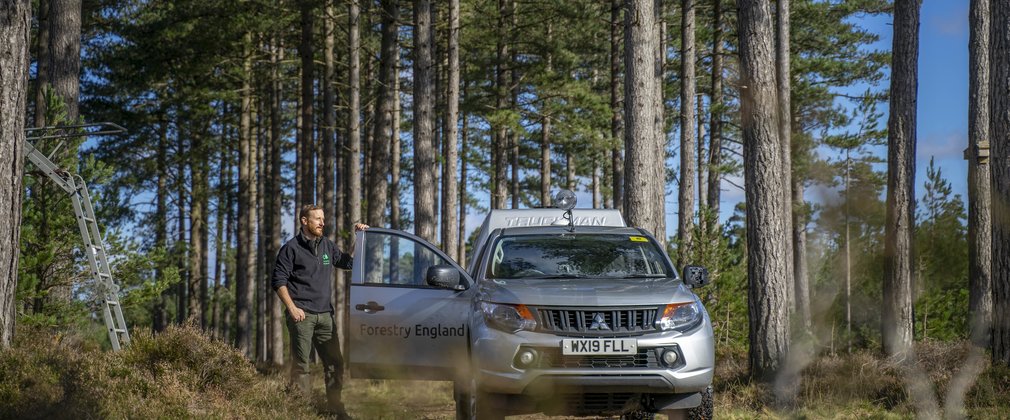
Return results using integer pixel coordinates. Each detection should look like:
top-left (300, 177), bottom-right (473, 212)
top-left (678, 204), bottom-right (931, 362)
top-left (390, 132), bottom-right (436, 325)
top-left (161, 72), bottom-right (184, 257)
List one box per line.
top-left (272, 204), bottom-right (369, 419)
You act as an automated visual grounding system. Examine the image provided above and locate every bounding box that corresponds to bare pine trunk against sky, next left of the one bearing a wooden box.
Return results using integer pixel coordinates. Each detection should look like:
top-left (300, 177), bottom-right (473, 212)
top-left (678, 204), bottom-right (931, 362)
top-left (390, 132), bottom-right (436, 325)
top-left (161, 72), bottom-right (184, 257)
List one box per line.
top-left (881, 0), bottom-right (922, 354)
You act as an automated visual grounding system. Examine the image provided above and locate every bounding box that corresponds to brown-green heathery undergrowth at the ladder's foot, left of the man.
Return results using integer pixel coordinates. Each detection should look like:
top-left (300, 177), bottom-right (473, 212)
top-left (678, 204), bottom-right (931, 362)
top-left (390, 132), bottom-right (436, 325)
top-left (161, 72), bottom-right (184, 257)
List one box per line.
top-left (0, 327), bottom-right (316, 419)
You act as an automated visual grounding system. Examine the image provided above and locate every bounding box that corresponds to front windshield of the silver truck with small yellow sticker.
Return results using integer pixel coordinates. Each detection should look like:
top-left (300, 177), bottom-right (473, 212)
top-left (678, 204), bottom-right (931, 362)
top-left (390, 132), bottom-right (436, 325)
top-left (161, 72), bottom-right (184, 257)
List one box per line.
top-left (488, 233), bottom-right (676, 279)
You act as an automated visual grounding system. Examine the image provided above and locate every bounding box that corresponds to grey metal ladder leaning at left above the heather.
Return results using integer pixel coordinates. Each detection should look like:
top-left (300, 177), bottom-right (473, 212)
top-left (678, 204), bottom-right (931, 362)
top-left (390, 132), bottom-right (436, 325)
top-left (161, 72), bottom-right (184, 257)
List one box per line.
top-left (24, 122), bottom-right (129, 351)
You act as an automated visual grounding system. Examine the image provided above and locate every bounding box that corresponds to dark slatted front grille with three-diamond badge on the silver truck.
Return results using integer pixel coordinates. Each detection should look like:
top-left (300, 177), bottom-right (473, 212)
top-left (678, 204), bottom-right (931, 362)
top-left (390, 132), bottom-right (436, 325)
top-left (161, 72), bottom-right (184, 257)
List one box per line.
top-left (536, 307), bottom-right (659, 337)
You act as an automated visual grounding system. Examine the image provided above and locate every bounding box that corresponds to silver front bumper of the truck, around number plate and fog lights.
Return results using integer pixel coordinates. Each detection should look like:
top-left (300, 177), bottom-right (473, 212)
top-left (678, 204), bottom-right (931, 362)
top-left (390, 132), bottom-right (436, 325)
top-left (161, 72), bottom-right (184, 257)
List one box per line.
top-left (472, 315), bottom-right (715, 398)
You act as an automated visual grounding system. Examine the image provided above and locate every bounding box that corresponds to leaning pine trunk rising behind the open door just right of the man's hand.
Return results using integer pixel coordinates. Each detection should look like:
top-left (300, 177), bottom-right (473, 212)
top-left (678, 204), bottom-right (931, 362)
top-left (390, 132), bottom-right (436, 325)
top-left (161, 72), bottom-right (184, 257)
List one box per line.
top-left (366, 0), bottom-right (400, 226)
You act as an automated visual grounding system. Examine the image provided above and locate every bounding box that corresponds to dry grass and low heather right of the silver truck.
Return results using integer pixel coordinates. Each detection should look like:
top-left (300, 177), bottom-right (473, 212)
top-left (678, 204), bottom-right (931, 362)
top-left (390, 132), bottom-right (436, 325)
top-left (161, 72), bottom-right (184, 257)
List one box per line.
top-left (715, 340), bottom-right (1010, 419)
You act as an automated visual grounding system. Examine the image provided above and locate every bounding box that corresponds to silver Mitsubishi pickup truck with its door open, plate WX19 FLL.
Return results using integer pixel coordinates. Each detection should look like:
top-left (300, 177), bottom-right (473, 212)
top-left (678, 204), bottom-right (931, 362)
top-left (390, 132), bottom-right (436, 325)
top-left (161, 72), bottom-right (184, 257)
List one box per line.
top-left (345, 194), bottom-right (715, 419)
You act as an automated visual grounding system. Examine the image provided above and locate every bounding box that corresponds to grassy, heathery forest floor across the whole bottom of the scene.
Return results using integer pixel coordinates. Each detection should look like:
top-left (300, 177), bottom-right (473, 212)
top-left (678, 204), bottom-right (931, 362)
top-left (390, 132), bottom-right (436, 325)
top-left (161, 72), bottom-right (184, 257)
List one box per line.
top-left (0, 327), bottom-right (1010, 420)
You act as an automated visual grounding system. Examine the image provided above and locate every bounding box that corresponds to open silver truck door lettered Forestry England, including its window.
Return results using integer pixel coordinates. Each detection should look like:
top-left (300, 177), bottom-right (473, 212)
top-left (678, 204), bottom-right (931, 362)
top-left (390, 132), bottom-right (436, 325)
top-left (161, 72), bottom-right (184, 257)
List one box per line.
top-left (346, 228), bottom-right (477, 381)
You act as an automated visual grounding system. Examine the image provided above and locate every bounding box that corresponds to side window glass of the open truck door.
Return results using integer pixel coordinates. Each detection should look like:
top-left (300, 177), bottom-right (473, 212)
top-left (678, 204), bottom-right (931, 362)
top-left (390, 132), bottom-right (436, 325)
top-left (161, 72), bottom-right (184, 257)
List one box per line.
top-left (364, 231), bottom-right (448, 286)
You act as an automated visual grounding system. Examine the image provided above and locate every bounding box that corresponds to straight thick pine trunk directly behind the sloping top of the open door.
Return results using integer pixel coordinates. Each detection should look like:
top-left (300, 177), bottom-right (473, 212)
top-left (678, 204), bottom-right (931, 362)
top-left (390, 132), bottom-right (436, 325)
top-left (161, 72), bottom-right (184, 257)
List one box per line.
top-left (416, 0), bottom-right (437, 243)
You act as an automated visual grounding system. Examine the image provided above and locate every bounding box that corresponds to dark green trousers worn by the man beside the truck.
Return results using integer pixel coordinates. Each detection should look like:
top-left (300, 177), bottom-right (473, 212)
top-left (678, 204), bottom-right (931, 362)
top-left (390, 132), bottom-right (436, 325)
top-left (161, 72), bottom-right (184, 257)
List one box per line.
top-left (286, 312), bottom-right (343, 412)
